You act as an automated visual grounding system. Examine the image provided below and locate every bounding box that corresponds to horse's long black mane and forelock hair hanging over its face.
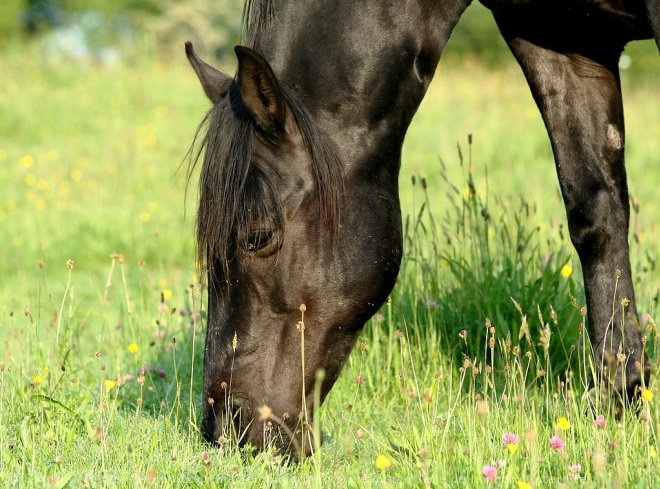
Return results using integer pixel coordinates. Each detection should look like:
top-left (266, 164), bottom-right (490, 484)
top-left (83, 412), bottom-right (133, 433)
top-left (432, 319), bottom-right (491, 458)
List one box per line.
top-left (189, 0), bottom-right (344, 289)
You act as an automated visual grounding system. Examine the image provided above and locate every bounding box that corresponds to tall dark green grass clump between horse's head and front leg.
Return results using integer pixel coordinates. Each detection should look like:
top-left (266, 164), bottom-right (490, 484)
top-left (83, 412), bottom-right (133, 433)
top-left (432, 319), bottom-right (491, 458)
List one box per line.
top-left (399, 138), bottom-right (584, 384)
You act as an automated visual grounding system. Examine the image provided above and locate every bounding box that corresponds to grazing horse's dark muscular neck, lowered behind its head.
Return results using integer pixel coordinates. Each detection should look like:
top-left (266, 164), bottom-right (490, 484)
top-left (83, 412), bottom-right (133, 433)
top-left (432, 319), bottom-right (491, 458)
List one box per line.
top-left (268, 0), bottom-right (471, 175)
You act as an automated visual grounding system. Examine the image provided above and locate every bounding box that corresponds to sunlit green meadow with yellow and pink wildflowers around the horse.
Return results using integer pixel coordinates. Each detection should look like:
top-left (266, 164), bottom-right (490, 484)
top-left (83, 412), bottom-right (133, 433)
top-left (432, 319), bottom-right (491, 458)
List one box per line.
top-left (0, 22), bottom-right (660, 489)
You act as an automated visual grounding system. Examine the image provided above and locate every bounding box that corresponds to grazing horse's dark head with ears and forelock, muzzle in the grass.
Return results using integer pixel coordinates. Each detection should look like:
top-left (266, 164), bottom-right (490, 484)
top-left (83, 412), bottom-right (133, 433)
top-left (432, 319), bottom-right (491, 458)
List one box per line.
top-left (186, 43), bottom-right (401, 455)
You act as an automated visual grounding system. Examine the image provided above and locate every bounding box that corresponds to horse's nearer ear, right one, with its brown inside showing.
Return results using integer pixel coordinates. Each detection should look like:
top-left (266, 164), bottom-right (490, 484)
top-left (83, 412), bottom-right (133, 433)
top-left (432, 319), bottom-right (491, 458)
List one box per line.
top-left (234, 46), bottom-right (286, 136)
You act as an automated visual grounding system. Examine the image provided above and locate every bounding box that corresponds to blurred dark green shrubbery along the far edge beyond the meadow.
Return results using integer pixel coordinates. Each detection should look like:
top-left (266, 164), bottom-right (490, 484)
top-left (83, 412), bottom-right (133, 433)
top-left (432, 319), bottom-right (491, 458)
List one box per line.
top-left (0, 0), bottom-right (657, 67)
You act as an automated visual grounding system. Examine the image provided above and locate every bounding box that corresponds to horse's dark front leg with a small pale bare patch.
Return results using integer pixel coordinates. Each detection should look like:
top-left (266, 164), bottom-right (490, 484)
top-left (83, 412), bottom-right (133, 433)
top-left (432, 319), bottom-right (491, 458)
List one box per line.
top-left (498, 19), bottom-right (650, 399)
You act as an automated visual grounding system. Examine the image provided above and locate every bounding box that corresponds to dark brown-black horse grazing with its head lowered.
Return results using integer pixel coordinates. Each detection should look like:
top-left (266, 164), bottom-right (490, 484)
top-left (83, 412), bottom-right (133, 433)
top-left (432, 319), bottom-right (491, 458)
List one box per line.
top-left (186, 0), bottom-right (660, 456)
